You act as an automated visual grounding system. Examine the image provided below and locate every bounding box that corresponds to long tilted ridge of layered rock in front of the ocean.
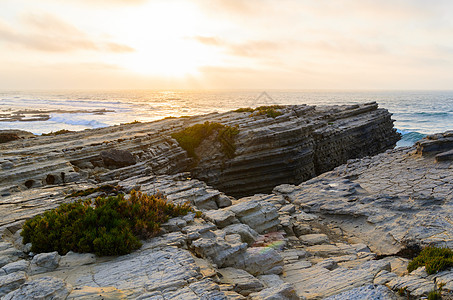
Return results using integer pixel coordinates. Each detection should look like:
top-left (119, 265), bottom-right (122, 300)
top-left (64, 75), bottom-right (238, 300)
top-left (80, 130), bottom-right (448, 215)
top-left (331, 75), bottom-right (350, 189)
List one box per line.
top-left (0, 103), bottom-right (399, 196)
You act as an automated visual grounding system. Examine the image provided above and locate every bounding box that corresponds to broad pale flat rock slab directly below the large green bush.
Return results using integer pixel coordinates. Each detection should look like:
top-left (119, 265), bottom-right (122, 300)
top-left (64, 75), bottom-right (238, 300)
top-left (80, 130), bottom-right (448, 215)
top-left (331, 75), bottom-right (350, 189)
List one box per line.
top-left (61, 246), bottom-right (230, 299)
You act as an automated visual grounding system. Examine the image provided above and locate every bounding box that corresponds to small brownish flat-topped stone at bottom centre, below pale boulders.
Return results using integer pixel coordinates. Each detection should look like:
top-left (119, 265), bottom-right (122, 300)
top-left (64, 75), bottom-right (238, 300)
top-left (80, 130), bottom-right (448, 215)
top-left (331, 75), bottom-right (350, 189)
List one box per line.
top-left (219, 268), bottom-right (264, 296)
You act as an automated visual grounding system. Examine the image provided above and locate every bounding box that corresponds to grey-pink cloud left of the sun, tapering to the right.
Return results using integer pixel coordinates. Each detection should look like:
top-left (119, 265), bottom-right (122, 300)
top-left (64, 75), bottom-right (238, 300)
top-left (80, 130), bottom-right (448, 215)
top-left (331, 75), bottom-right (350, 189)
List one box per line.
top-left (0, 14), bottom-right (135, 53)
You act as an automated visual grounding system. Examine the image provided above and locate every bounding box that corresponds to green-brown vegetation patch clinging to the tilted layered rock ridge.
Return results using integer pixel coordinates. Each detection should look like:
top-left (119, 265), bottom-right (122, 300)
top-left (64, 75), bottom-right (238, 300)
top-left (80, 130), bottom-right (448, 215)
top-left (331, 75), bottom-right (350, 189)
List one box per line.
top-left (171, 121), bottom-right (239, 160)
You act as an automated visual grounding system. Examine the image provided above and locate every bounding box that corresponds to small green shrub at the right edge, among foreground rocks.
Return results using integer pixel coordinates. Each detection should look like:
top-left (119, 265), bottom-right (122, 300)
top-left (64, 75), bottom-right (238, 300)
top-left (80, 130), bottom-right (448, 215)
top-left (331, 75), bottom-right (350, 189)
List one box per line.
top-left (407, 247), bottom-right (453, 275)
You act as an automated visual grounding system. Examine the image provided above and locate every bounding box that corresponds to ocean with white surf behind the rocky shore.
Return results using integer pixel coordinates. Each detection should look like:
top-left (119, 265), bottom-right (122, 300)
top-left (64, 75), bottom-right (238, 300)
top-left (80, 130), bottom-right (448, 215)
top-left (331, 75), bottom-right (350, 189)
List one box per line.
top-left (0, 90), bottom-right (453, 146)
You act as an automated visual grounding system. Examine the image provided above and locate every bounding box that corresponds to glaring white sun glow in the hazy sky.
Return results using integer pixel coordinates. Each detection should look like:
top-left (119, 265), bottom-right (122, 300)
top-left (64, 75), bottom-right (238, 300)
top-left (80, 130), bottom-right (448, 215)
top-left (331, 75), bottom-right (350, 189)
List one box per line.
top-left (112, 1), bottom-right (219, 77)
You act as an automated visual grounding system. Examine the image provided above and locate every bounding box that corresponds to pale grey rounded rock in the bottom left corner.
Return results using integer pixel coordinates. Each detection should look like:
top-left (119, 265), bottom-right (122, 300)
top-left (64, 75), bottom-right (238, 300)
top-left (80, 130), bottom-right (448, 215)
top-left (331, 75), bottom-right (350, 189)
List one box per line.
top-left (3, 276), bottom-right (72, 300)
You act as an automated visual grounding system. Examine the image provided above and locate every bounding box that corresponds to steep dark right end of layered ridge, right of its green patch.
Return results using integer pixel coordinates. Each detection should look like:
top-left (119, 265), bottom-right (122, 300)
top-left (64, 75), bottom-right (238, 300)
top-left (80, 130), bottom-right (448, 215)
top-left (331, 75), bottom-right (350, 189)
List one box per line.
top-left (192, 103), bottom-right (399, 197)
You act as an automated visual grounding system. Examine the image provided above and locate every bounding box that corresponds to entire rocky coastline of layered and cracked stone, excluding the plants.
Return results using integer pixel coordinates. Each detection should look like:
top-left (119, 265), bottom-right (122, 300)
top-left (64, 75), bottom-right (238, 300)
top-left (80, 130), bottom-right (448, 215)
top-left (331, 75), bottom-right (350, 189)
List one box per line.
top-left (0, 103), bottom-right (453, 299)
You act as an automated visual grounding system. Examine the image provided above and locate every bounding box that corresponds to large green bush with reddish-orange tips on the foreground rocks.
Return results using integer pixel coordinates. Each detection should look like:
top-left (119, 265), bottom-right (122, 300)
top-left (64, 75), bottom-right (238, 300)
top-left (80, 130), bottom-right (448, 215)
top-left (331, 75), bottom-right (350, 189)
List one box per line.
top-left (21, 191), bottom-right (192, 256)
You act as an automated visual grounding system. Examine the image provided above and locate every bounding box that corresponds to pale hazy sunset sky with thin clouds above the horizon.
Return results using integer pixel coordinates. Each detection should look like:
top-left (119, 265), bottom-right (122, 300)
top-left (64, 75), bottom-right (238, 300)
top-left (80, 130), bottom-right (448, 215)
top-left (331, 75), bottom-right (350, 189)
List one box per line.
top-left (0, 0), bottom-right (453, 90)
